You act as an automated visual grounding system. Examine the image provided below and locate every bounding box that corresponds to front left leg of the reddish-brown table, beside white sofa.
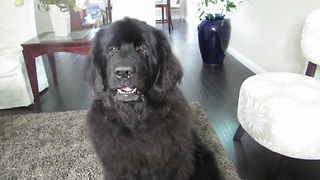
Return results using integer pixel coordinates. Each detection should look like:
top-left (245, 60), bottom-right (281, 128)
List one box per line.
top-left (22, 50), bottom-right (41, 110)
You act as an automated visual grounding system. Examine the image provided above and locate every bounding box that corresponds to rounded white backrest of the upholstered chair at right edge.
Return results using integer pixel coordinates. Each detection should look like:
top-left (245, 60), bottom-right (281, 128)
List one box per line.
top-left (301, 8), bottom-right (320, 65)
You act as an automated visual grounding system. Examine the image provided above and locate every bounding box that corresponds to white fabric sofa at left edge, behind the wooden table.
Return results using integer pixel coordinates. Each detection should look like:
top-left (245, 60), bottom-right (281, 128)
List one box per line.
top-left (0, 1), bottom-right (48, 109)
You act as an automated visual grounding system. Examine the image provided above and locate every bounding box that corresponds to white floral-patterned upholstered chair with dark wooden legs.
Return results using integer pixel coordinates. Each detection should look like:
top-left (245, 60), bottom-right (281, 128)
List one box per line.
top-left (234, 8), bottom-right (320, 177)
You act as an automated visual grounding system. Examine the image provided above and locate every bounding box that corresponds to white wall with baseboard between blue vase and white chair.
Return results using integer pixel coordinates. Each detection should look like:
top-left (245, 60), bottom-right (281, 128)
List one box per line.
top-left (184, 0), bottom-right (320, 76)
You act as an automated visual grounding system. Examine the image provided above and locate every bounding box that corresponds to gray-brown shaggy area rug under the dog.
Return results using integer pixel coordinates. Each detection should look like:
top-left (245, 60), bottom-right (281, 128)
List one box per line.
top-left (0, 102), bottom-right (239, 180)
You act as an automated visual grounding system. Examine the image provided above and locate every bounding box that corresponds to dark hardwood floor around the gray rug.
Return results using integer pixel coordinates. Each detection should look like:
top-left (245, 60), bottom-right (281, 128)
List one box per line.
top-left (0, 21), bottom-right (320, 180)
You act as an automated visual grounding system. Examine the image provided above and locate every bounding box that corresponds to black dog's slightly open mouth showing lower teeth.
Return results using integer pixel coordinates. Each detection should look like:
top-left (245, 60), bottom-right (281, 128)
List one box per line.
top-left (114, 86), bottom-right (144, 101)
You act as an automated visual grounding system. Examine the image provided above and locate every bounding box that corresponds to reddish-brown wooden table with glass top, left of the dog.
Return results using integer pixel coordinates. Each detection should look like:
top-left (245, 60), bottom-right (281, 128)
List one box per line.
top-left (21, 29), bottom-right (97, 110)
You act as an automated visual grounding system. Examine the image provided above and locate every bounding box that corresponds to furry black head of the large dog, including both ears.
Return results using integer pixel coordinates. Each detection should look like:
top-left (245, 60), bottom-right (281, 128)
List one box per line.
top-left (82, 18), bottom-right (183, 102)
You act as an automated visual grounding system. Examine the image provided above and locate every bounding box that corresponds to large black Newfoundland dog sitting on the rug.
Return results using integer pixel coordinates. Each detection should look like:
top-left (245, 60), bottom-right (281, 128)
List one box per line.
top-left (86, 18), bottom-right (220, 180)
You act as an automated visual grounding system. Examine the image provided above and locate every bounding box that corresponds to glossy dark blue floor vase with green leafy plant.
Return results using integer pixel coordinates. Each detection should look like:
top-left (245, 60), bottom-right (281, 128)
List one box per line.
top-left (196, 0), bottom-right (242, 65)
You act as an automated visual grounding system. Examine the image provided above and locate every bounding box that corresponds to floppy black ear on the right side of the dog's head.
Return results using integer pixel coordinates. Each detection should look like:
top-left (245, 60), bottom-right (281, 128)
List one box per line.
top-left (154, 37), bottom-right (183, 92)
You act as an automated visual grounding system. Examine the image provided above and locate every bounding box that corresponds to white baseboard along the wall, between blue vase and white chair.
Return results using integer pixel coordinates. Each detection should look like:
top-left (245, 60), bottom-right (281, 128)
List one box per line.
top-left (227, 46), bottom-right (267, 74)
